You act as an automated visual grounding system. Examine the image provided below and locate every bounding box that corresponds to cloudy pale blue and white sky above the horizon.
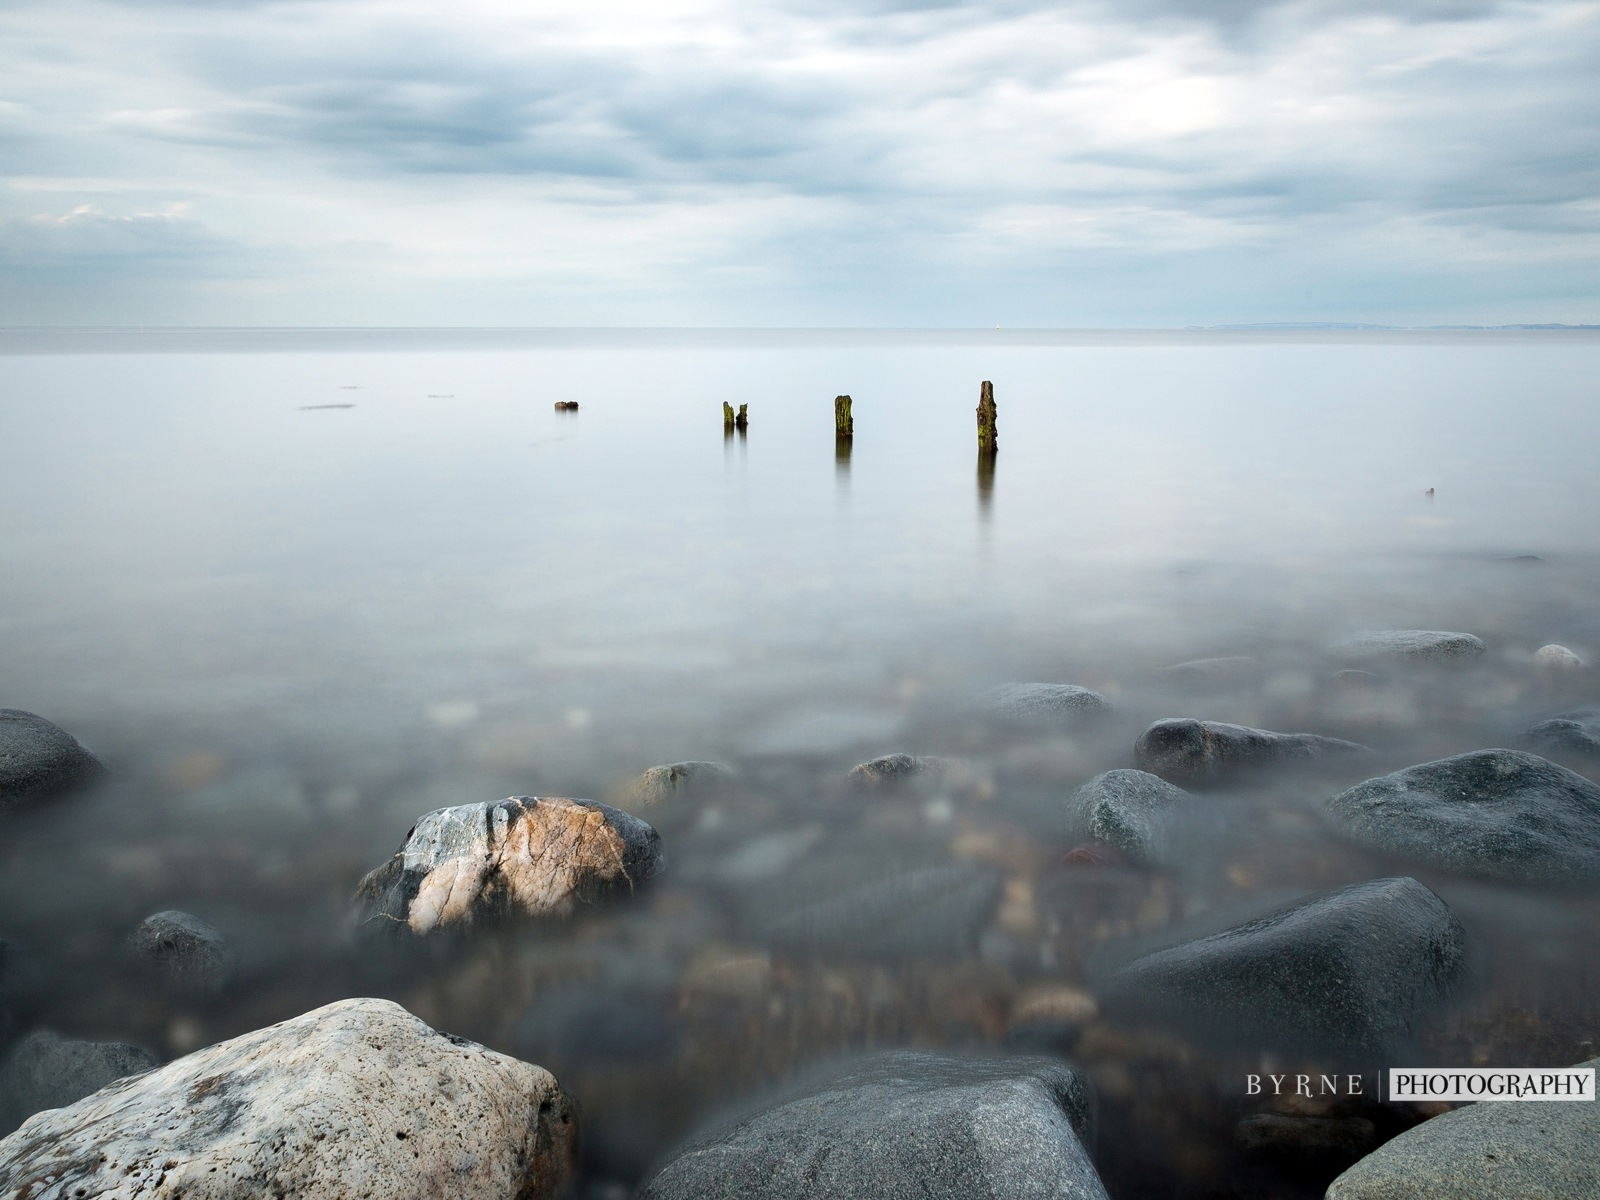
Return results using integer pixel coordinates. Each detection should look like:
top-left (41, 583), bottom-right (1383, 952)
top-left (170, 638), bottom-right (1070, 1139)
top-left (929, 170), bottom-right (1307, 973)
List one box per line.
top-left (0, 0), bottom-right (1600, 328)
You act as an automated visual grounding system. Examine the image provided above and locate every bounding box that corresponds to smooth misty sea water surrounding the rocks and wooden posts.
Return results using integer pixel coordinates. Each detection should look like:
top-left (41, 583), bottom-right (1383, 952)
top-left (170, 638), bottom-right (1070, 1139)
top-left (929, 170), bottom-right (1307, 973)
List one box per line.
top-left (0, 331), bottom-right (1600, 1197)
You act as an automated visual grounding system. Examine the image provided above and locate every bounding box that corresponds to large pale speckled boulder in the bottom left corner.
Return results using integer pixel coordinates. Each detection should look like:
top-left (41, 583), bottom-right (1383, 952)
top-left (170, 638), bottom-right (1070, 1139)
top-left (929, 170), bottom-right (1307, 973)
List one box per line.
top-left (0, 1000), bottom-right (576, 1200)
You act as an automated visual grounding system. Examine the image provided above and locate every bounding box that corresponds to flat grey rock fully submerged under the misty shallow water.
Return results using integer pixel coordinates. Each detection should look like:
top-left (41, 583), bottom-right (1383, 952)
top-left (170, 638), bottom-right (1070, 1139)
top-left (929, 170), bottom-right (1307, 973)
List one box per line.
top-left (755, 866), bottom-right (1000, 958)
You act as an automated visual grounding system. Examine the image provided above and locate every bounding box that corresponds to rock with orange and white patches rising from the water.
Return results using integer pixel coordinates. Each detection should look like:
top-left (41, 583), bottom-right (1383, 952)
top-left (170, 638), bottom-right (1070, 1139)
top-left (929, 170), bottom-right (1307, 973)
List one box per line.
top-left (355, 795), bottom-right (664, 933)
